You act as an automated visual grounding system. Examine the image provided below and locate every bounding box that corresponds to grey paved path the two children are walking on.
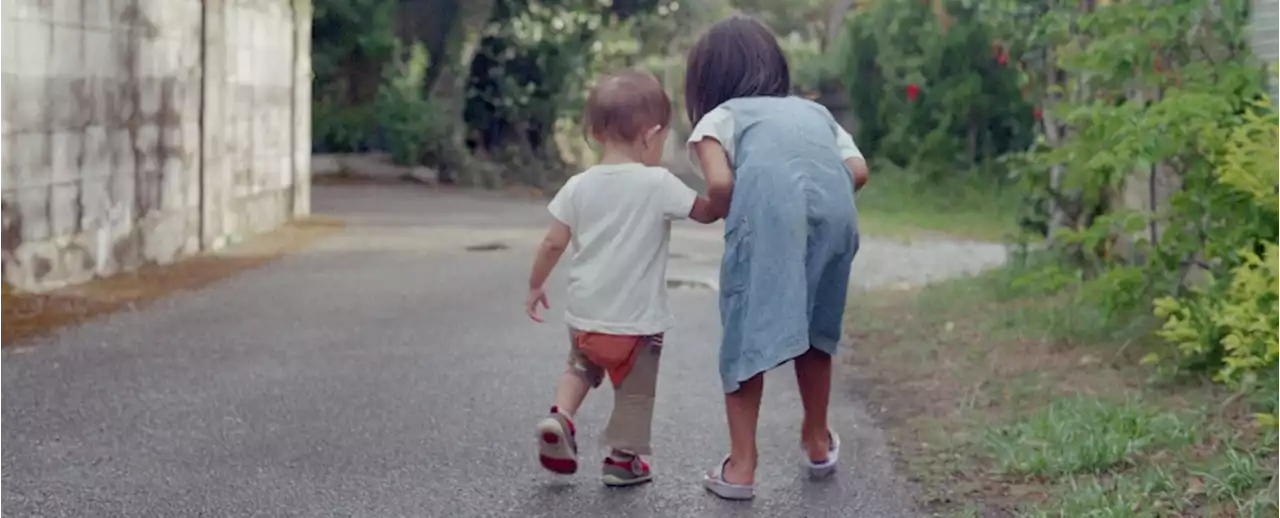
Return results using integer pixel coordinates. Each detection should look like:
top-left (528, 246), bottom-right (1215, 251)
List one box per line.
top-left (0, 187), bottom-right (995, 518)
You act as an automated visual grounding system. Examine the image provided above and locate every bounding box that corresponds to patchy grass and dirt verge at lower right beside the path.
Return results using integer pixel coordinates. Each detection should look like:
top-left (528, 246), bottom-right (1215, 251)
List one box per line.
top-left (850, 265), bottom-right (1280, 518)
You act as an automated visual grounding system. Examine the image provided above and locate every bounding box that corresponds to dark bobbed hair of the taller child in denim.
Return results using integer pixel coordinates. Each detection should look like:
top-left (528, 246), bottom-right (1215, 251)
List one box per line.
top-left (685, 15), bottom-right (791, 124)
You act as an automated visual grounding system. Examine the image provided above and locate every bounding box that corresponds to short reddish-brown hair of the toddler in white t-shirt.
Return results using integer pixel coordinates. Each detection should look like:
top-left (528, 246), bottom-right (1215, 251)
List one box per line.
top-left (584, 70), bottom-right (671, 142)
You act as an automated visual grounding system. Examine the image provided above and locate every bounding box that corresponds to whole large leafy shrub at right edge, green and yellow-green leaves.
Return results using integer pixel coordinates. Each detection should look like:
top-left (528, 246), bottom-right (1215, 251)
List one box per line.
top-left (988, 0), bottom-right (1280, 396)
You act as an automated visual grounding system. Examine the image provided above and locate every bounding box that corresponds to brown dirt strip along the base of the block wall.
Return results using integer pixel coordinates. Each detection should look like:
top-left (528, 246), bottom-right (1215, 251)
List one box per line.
top-left (0, 217), bottom-right (343, 347)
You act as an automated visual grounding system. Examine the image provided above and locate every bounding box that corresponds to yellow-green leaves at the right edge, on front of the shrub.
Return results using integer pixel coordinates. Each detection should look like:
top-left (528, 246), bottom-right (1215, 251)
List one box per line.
top-left (1156, 99), bottom-right (1280, 385)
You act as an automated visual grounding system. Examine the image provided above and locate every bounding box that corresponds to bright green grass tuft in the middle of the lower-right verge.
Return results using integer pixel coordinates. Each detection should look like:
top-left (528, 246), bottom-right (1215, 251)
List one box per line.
top-left (986, 396), bottom-right (1198, 478)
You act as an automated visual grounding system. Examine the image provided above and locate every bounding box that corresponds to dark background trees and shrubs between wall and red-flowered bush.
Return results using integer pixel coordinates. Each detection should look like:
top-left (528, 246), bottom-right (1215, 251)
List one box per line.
top-left (314, 0), bottom-right (852, 187)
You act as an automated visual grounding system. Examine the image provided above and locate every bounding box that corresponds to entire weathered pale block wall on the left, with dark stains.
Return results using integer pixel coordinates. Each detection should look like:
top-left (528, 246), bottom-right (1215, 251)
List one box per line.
top-left (0, 0), bottom-right (310, 290)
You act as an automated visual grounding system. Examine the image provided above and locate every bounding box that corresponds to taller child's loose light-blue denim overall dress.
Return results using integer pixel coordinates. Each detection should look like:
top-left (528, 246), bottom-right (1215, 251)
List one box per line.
top-left (719, 97), bottom-right (859, 393)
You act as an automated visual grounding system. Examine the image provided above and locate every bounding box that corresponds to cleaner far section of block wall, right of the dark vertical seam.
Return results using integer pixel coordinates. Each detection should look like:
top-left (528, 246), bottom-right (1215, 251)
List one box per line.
top-left (205, 0), bottom-right (304, 247)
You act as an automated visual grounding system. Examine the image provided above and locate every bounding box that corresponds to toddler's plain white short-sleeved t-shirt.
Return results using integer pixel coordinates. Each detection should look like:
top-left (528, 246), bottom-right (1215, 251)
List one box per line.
top-left (548, 164), bottom-right (698, 335)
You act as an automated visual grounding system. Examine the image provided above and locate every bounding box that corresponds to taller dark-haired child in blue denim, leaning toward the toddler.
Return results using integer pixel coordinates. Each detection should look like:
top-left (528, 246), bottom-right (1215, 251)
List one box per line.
top-left (685, 17), bottom-right (867, 499)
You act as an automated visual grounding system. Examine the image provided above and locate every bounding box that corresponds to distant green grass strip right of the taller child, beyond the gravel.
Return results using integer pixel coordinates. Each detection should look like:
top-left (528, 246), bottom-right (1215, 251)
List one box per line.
top-left (858, 165), bottom-right (1019, 242)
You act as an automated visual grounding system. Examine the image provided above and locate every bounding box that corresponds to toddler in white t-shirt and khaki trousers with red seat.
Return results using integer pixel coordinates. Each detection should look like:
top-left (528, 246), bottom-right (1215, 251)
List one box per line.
top-left (526, 72), bottom-right (718, 486)
